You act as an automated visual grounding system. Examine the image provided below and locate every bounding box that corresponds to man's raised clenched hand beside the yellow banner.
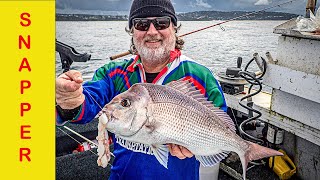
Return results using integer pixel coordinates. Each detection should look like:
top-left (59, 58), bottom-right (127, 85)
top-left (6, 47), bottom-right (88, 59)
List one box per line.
top-left (56, 70), bottom-right (84, 109)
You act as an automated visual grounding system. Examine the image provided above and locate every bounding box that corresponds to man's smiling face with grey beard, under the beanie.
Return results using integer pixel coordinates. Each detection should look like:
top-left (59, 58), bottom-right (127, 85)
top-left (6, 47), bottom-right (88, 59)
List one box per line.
top-left (133, 17), bottom-right (176, 66)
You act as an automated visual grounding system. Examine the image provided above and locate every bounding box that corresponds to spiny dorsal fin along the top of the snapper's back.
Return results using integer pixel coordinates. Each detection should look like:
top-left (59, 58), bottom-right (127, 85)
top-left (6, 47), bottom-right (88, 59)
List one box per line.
top-left (166, 79), bottom-right (236, 132)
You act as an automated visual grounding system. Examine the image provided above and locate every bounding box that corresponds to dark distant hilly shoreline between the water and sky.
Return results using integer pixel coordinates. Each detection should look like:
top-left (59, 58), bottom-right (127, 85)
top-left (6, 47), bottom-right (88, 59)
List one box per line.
top-left (56, 11), bottom-right (298, 21)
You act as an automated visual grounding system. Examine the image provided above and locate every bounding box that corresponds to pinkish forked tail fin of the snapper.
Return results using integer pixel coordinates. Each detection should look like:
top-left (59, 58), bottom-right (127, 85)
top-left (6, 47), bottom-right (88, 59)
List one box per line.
top-left (240, 141), bottom-right (283, 179)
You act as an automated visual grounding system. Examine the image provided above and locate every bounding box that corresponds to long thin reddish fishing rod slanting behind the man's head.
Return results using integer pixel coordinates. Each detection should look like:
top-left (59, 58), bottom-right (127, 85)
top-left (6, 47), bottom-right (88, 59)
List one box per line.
top-left (109, 0), bottom-right (297, 60)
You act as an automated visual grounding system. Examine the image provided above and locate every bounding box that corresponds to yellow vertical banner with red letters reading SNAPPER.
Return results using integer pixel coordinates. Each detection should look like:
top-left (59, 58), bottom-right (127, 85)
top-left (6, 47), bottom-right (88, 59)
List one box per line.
top-left (0, 1), bottom-right (55, 180)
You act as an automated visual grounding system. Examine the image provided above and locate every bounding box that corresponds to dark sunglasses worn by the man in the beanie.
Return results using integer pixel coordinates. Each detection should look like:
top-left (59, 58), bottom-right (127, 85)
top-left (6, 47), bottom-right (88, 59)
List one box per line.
top-left (132, 16), bottom-right (171, 31)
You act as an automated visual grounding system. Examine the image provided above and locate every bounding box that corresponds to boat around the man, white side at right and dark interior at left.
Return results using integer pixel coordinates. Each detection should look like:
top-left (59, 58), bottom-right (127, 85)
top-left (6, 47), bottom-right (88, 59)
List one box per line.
top-left (56, 1), bottom-right (320, 180)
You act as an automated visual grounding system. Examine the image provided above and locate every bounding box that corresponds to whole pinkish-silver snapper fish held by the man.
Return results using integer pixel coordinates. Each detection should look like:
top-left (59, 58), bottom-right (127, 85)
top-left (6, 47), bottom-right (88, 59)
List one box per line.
top-left (99, 80), bottom-right (283, 179)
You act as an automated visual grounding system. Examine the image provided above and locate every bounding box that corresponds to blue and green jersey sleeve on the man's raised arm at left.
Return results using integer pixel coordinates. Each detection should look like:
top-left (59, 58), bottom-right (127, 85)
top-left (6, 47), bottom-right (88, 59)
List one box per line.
top-left (56, 67), bottom-right (115, 124)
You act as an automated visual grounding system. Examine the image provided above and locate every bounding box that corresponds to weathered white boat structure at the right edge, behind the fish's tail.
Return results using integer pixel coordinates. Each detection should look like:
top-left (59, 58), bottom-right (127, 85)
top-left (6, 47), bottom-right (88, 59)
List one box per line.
top-left (218, 1), bottom-right (320, 180)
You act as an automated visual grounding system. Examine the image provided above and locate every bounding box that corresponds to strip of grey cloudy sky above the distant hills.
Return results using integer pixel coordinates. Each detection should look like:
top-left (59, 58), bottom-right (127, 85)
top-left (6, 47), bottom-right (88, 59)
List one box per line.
top-left (56, 0), bottom-right (312, 14)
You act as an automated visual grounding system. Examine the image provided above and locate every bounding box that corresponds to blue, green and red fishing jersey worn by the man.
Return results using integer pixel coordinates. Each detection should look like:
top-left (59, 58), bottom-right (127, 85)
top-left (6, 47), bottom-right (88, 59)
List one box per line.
top-left (57, 50), bottom-right (227, 180)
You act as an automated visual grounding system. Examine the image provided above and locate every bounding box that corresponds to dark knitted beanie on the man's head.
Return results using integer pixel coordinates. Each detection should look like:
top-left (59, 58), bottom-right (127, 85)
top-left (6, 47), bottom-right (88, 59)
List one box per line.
top-left (129, 0), bottom-right (177, 29)
